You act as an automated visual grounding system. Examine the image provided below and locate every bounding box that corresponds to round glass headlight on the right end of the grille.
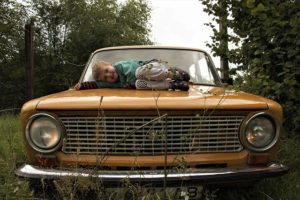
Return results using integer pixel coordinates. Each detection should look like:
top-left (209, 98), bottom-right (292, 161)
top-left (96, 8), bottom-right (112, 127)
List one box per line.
top-left (241, 113), bottom-right (280, 152)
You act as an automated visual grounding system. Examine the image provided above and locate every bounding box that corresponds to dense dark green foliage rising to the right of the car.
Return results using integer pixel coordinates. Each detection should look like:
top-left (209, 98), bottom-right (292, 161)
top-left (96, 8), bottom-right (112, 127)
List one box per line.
top-left (201, 0), bottom-right (300, 134)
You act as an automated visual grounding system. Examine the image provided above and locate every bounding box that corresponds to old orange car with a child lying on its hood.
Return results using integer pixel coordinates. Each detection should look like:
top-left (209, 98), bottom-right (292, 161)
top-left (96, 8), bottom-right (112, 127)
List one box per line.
top-left (16, 46), bottom-right (288, 185)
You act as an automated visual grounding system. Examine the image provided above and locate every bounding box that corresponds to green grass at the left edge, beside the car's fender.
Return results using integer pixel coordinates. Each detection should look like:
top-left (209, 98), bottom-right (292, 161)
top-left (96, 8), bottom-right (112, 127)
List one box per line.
top-left (0, 114), bottom-right (32, 199)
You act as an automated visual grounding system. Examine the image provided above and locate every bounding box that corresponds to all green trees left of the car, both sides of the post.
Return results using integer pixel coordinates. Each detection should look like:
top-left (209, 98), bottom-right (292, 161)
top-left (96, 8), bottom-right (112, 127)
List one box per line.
top-left (0, 0), bottom-right (151, 109)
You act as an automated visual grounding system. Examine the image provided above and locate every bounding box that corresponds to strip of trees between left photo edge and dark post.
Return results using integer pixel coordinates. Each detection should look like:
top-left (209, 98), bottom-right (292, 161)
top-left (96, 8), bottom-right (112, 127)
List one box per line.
top-left (0, 0), bottom-right (28, 110)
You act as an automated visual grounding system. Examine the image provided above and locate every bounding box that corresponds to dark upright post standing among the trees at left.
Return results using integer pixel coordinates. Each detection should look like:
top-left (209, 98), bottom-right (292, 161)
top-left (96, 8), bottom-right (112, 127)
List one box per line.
top-left (25, 22), bottom-right (33, 100)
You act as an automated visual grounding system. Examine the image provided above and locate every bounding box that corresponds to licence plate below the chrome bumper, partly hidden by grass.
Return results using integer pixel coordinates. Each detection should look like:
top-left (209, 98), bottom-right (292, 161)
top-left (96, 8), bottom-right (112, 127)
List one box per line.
top-left (106, 186), bottom-right (203, 200)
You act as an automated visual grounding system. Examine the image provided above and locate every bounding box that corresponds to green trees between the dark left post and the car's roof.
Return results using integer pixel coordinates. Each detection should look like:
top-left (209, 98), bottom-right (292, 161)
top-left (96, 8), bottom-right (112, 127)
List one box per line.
top-left (32, 0), bottom-right (150, 95)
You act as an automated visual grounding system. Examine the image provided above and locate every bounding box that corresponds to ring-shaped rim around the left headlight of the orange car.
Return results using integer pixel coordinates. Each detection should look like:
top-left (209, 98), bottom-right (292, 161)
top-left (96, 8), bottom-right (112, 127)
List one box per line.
top-left (25, 112), bottom-right (65, 154)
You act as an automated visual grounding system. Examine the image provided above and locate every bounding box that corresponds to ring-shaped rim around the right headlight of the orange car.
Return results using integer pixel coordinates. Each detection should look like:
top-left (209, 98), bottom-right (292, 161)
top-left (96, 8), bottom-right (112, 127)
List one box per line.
top-left (239, 111), bottom-right (281, 152)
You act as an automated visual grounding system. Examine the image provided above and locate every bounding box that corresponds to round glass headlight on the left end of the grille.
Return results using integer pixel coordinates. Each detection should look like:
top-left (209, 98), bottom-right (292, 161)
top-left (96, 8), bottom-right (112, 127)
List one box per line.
top-left (26, 113), bottom-right (62, 153)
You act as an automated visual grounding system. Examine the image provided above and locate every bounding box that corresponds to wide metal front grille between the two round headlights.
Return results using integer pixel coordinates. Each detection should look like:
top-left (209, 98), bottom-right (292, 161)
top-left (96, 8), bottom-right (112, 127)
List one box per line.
top-left (60, 115), bottom-right (244, 155)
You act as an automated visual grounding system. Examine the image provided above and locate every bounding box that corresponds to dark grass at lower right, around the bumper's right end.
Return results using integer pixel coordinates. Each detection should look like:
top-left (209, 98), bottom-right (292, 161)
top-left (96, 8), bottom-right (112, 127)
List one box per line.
top-left (213, 135), bottom-right (300, 200)
